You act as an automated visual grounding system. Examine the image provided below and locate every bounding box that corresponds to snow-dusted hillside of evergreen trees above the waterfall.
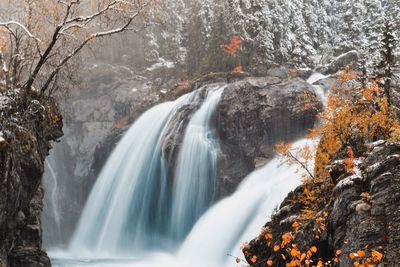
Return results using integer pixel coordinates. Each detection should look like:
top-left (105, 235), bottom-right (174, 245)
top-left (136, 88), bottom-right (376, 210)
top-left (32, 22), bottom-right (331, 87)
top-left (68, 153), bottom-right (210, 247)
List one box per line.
top-left (137, 0), bottom-right (400, 76)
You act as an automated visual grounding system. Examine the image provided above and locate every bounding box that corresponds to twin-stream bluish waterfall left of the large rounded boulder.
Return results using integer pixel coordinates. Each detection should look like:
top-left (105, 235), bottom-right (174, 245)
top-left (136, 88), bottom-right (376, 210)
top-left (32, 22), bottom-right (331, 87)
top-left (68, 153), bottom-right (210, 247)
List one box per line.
top-left (70, 86), bottom-right (223, 258)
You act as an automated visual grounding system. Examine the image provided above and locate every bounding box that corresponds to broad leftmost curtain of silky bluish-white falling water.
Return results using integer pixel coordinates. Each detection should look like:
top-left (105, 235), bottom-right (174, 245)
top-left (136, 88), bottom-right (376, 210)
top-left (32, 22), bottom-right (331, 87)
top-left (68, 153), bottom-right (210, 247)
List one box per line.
top-left (70, 102), bottom-right (175, 256)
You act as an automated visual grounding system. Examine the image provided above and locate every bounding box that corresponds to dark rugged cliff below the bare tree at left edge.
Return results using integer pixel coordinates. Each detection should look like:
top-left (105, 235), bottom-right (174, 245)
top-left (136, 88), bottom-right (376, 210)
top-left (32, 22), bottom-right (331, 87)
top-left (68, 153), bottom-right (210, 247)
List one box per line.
top-left (0, 92), bottom-right (62, 267)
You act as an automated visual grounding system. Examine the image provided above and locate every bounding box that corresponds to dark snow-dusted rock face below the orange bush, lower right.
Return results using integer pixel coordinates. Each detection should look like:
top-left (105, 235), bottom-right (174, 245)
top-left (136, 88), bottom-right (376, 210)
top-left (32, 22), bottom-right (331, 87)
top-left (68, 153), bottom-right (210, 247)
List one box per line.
top-left (245, 142), bottom-right (400, 266)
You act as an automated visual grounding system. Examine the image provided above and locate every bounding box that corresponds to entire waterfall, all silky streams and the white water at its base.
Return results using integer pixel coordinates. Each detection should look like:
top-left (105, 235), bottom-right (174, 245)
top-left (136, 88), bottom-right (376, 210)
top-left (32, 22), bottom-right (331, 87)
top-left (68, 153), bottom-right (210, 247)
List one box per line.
top-left (50, 75), bottom-right (324, 267)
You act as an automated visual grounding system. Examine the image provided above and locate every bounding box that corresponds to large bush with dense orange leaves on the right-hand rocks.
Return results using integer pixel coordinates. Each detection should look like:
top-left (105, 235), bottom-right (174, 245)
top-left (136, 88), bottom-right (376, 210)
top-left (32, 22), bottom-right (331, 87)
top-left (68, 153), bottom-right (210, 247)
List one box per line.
top-left (310, 71), bottom-right (400, 178)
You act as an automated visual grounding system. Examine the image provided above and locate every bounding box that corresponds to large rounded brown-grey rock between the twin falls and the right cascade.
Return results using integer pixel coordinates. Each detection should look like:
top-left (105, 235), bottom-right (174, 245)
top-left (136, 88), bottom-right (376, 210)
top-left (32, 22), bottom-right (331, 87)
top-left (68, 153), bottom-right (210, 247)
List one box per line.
top-left (216, 76), bottom-right (320, 197)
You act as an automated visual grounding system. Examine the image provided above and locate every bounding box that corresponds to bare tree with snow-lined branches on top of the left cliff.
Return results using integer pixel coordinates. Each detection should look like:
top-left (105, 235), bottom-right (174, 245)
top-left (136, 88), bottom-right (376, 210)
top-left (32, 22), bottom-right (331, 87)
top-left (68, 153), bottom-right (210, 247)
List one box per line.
top-left (0, 0), bottom-right (155, 100)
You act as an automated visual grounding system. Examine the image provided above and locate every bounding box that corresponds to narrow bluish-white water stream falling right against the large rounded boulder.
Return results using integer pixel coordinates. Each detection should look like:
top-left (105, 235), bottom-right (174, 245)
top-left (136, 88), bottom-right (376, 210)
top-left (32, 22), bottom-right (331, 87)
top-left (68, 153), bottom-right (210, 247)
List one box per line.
top-left (171, 88), bottom-right (224, 240)
